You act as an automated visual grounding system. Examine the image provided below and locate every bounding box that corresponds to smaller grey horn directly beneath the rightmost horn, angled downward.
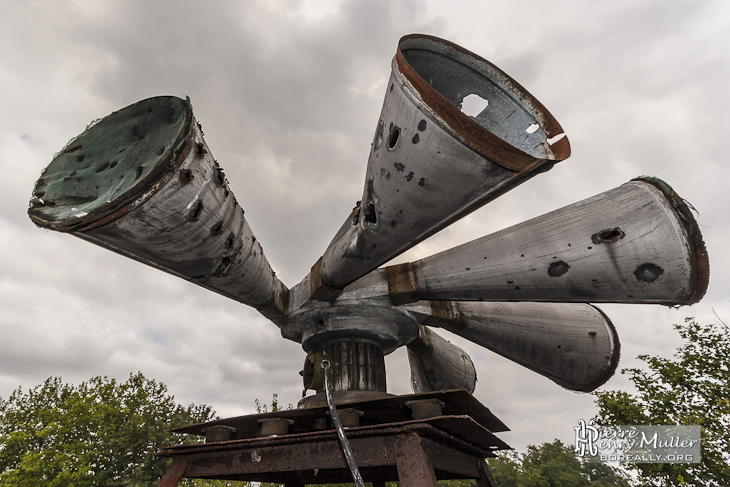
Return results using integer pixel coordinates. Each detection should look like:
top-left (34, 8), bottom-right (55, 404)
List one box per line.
top-left (404, 301), bottom-right (620, 392)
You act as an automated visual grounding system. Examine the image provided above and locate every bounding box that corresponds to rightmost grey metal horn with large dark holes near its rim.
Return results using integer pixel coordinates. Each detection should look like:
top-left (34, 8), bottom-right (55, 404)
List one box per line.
top-left (385, 177), bottom-right (710, 306)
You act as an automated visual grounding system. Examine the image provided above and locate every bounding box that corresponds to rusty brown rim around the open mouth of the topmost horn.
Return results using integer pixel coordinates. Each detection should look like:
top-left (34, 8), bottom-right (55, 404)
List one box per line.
top-left (395, 34), bottom-right (570, 172)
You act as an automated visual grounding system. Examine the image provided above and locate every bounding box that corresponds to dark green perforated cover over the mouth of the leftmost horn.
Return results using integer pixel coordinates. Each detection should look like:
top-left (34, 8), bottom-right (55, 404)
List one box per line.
top-left (28, 96), bottom-right (193, 231)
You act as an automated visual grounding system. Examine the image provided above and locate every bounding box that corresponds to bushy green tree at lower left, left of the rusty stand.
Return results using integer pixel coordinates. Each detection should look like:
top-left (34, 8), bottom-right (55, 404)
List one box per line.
top-left (0, 373), bottom-right (214, 487)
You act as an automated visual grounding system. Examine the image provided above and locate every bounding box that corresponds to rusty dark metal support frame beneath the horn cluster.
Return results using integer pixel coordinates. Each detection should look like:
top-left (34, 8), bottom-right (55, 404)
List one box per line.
top-left (158, 390), bottom-right (508, 487)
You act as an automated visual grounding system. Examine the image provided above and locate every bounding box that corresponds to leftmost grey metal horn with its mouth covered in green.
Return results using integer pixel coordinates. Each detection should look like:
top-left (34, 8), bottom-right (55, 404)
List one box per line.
top-left (28, 96), bottom-right (287, 316)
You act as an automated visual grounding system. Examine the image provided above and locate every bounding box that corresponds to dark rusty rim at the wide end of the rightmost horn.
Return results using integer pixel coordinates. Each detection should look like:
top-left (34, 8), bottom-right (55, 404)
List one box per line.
top-left (632, 176), bottom-right (710, 305)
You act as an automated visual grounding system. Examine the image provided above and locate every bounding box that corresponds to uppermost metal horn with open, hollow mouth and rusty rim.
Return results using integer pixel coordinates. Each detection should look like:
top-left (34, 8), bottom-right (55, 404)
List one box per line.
top-left (312, 35), bottom-right (570, 299)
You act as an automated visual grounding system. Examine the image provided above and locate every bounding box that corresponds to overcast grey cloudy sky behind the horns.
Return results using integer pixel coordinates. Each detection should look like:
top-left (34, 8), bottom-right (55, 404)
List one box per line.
top-left (0, 0), bottom-right (730, 449)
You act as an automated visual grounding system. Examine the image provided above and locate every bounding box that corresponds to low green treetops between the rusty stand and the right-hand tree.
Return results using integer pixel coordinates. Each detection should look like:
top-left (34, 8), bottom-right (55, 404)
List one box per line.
top-left (489, 440), bottom-right (631, 487)
